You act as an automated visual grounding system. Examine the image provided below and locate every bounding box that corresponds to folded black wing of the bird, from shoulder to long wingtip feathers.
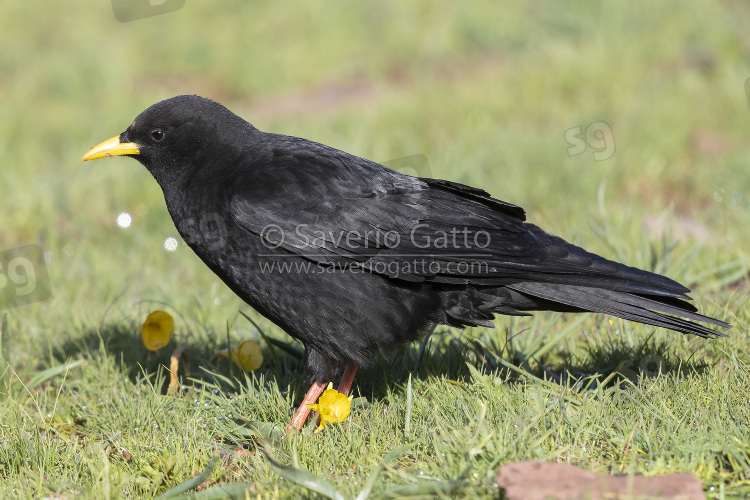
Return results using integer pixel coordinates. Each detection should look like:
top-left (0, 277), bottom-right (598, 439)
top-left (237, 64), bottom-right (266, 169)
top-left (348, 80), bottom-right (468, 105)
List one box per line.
top-left (230, 139), bottom-right (689, 298)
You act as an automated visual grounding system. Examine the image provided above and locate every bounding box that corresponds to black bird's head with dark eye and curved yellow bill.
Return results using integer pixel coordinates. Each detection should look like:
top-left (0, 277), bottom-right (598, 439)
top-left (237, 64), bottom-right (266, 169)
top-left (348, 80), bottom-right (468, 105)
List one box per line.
top-left (81, 95), bottom-right (257, 186)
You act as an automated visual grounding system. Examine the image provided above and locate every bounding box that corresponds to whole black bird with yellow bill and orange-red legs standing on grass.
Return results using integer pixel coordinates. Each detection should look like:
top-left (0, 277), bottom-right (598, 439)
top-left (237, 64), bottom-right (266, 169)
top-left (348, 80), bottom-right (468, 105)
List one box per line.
top-left (82, 96), bottom-right (730, 428)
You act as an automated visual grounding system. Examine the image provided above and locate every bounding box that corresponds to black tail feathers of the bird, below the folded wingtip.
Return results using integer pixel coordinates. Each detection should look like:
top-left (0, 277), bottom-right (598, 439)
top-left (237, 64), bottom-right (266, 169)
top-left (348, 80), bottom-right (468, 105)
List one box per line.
top-left (508, 282), bottom-right (731, 338)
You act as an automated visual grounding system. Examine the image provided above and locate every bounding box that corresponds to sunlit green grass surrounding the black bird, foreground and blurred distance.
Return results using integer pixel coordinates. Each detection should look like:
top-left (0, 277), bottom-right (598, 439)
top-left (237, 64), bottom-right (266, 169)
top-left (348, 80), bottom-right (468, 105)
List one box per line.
top-left (0, 0), bottom-right (750, 498)
